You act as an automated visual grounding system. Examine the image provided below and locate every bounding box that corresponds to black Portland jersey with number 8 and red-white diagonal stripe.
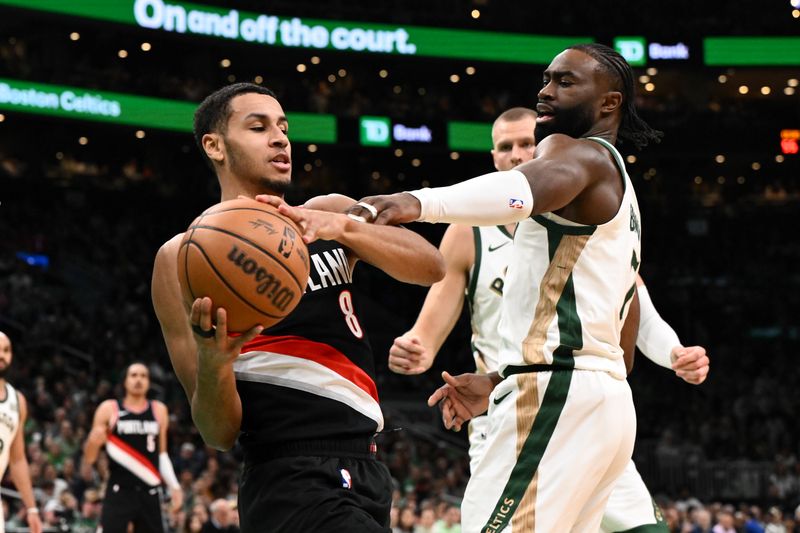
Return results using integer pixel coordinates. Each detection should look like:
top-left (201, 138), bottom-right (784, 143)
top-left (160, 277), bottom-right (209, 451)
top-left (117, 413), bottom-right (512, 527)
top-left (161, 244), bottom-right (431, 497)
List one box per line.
top-left (234, 241), bottom-right (383, 452)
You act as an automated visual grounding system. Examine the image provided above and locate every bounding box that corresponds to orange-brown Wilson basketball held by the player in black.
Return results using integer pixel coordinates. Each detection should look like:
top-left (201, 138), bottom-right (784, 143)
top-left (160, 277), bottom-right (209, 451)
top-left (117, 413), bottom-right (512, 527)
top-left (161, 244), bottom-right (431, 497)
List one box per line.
top-left (178, 198), bottom-right (309, 332)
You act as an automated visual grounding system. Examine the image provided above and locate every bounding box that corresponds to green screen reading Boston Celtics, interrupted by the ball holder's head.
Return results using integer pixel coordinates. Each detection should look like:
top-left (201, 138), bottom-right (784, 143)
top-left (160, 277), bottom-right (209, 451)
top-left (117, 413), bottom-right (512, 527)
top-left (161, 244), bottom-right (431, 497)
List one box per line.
top-left (0, 78), bottom-right (337, 143)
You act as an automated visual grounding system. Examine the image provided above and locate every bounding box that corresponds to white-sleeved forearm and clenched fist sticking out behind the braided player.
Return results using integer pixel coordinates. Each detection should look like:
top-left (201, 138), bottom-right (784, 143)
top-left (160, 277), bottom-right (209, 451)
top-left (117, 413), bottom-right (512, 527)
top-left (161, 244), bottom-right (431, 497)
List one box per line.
top-left (636, 276), bottom-right (710, 385)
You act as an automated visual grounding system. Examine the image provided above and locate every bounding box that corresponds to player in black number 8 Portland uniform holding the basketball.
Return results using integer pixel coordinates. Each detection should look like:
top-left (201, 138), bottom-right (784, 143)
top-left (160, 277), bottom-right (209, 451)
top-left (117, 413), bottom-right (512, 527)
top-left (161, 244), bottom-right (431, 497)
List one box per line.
top-left (152, 83), bottom-right (444, 533)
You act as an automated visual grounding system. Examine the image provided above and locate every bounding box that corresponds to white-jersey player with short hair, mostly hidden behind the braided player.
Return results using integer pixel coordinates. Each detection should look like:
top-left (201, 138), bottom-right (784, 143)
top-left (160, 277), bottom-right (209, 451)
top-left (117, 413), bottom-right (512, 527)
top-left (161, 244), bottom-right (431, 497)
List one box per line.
top-left (389, 107), bottom-right (709, 533)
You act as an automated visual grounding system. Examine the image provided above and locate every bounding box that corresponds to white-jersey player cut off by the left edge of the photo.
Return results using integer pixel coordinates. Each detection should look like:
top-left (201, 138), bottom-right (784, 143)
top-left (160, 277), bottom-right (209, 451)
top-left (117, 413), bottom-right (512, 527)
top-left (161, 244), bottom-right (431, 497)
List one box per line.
top-left (0, 331), bottom-right (42, 533)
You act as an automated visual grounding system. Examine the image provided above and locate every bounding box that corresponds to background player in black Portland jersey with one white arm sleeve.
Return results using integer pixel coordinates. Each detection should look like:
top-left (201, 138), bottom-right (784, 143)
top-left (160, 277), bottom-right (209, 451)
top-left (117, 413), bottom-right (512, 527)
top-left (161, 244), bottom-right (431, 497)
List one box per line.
top-left (83, 363), bottom-right (183, 533)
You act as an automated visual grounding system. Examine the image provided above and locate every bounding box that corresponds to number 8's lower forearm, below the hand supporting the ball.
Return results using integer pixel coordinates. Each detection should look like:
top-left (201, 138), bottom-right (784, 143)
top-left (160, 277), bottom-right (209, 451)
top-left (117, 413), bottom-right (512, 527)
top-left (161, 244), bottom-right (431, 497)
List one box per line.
top-left (192, 361), bottom-right (242, 450)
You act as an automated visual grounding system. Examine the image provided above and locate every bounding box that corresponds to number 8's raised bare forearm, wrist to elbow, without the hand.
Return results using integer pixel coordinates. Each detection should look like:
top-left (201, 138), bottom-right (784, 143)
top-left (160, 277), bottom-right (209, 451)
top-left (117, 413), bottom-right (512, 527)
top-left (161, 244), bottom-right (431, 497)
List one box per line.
top-left (337, 219), bottom-right (444, 285)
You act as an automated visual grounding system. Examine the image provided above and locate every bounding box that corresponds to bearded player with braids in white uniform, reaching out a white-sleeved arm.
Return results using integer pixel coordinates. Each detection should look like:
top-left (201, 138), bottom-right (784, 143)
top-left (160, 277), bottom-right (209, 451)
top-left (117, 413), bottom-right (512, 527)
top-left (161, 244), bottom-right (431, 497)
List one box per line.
top-left (334, 44), bottom-right (708, 533)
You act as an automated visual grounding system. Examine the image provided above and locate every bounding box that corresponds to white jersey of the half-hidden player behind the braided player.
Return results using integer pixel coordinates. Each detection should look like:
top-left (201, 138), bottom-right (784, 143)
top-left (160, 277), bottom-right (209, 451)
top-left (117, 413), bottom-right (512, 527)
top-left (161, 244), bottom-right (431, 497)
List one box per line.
top-left (467, 226), bottom-right (514, 373)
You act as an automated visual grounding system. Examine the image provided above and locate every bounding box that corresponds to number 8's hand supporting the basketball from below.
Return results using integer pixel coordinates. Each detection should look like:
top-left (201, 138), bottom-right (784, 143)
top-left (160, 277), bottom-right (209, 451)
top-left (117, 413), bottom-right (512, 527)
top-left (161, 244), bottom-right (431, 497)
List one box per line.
top-left (190, 297), bottom-right (264, 368)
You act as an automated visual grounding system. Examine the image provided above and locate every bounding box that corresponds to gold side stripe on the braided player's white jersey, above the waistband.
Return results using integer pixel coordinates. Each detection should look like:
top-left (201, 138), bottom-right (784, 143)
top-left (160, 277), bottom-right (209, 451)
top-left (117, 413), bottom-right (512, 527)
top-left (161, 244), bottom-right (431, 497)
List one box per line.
top-left (522, 235), bottom-right (591, 365)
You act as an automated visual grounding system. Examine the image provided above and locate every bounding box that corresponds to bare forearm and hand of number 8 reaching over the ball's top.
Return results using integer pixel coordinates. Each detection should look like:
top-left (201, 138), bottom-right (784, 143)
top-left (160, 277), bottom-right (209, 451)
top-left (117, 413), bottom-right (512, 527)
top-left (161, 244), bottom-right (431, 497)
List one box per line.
top-left (256, 195), bottom-right (444, 285)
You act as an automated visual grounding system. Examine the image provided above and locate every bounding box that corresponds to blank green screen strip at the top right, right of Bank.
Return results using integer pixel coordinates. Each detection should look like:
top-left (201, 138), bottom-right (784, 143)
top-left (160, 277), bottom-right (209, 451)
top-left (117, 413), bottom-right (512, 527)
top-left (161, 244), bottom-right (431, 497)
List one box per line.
top-left (703, 37), bottom-right (800, 66)
